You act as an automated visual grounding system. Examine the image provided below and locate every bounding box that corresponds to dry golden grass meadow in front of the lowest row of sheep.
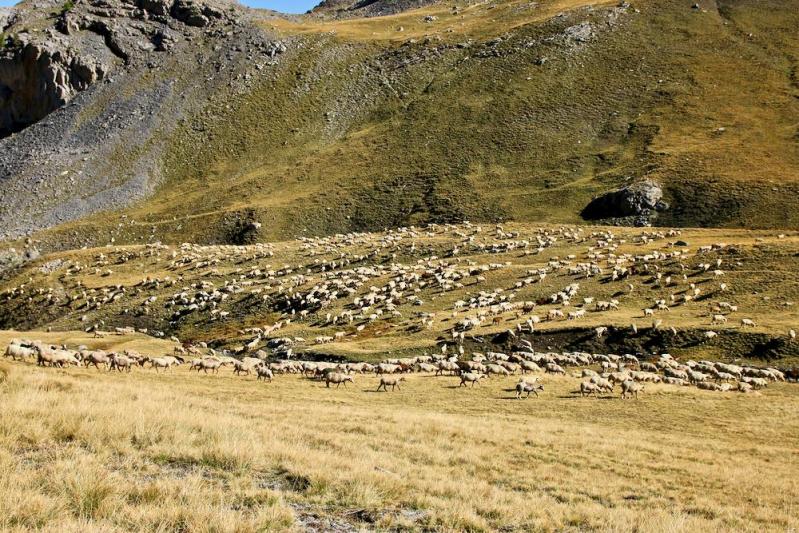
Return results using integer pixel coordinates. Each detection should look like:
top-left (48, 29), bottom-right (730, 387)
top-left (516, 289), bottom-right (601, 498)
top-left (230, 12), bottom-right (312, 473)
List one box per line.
top-left (0, 356), bottom-right (799, 531)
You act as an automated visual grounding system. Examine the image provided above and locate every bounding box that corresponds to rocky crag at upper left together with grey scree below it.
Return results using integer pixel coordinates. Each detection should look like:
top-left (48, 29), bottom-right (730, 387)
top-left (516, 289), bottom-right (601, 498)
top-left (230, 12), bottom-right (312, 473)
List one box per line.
top-left (0, 0), bottom-right (287, 240)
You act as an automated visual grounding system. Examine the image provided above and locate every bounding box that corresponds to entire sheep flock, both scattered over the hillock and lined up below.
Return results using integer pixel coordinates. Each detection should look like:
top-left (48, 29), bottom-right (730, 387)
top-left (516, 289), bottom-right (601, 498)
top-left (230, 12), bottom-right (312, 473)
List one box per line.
top-left (0, 218), bottom-right (796, 398)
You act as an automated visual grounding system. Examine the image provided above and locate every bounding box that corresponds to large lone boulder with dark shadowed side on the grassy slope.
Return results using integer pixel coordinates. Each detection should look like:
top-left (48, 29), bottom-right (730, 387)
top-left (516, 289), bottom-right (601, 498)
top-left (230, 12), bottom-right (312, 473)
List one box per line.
top-left (580, 180), bottom-right (669, 226)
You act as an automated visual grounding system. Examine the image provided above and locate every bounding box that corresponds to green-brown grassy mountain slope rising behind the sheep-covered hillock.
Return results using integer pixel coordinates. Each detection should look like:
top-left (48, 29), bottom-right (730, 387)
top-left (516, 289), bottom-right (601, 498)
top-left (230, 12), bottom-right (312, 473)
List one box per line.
top-left (0, 0), bottom-right (799, 251)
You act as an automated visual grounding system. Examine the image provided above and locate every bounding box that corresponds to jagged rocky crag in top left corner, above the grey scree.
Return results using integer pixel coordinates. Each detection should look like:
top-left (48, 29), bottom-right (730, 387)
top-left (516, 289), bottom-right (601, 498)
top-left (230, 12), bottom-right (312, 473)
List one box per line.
top-left (0, 0), bottom-right (237, 138)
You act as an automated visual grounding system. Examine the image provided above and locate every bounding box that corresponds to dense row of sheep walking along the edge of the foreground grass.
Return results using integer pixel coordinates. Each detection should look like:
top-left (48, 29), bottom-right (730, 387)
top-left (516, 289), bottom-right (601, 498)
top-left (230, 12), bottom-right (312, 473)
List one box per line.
top-left (5, 339), bottom-right (785, 399)
